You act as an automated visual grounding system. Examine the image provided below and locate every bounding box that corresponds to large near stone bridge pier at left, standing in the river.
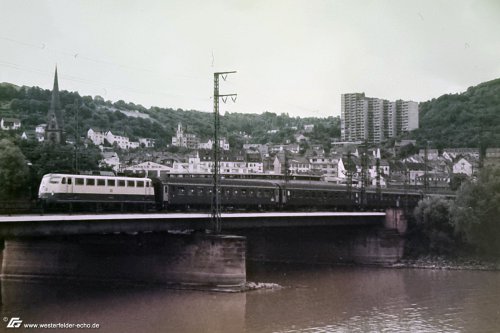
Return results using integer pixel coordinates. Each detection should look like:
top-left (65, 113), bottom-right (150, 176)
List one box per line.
top-left (1, 232), bottom-right (246, 291)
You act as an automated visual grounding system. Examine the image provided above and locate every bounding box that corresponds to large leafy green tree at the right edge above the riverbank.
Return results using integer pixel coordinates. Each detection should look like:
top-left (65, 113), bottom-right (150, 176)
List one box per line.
top-left (451, 168), bottom-right (500, 257)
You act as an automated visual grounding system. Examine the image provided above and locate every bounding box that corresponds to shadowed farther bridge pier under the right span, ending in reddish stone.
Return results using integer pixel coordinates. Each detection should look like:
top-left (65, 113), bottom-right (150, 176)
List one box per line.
top-left (242, 209), bottom-right (406, 265)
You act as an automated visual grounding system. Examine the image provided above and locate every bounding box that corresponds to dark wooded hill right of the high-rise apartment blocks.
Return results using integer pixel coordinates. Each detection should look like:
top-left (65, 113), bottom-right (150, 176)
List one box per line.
top-left (412, 79), bottom-right (500, 149)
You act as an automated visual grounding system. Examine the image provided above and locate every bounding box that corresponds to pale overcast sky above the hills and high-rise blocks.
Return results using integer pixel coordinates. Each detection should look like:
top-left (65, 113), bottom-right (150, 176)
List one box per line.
top-left (0, 0), bottom-right (500, 117)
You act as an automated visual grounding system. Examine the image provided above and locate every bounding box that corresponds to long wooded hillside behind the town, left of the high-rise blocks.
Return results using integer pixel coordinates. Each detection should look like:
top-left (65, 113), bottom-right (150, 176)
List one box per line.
top-left (0, 83), bottom-right (340, 148)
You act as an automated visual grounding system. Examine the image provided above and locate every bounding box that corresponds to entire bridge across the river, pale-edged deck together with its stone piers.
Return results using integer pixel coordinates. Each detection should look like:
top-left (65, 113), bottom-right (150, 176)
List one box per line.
top-left (0, 209), bottom-right (406, 291)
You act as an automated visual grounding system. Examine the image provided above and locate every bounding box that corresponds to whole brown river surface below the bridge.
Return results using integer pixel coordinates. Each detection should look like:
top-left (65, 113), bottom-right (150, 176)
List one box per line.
top-left (0, 264), bottom-right (500, 333)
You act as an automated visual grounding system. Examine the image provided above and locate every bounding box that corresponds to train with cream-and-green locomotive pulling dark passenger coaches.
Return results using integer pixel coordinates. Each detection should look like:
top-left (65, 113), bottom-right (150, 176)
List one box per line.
top-left (38, 173), bottom-right (422, 211)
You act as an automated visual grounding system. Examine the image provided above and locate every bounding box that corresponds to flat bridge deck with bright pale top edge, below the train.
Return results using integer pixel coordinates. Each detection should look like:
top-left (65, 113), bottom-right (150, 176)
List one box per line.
top-left (0, 212), bottom-right (386, 238)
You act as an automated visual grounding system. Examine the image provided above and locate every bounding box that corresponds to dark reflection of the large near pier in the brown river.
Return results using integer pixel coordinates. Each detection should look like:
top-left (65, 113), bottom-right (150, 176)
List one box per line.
top-left (0, 281), bottom-right (246, 333)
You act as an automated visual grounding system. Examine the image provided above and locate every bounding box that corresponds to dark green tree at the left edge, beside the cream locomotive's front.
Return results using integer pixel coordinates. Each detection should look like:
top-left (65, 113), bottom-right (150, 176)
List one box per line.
top-left (0, 139), bottom-right (29, 200)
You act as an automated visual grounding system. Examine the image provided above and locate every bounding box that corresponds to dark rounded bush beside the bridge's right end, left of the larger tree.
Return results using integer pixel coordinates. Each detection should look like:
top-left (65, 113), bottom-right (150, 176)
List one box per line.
top-left (411, 197), bottom-right (457, 254)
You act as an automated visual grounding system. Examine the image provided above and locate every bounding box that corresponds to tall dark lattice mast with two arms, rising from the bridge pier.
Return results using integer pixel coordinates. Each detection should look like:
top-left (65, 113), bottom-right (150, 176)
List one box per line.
top-left (211, 71), bottom-right (237, 234)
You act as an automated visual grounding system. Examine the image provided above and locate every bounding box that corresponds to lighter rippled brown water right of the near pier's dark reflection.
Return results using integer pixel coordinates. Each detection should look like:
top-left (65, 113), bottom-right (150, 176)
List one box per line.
top-left (246, 267), bottom-right (500, 332)
